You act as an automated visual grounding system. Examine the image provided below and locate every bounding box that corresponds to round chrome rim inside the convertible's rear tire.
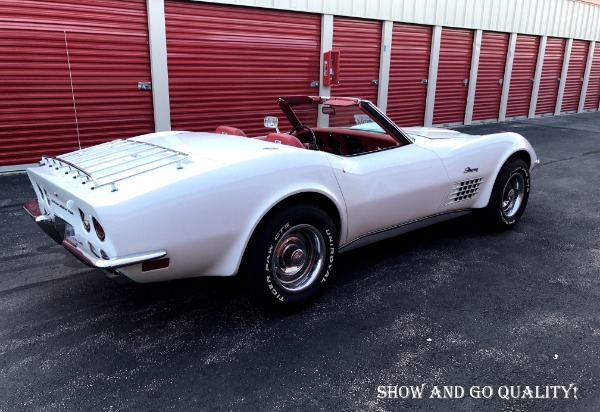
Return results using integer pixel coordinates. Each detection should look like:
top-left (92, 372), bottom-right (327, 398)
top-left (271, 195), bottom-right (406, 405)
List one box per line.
top-left (271, 224), bottom-right (325, 293)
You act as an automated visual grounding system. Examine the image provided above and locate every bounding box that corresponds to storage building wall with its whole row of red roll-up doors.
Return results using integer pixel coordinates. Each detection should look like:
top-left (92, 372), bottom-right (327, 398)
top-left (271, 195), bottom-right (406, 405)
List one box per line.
top-left (0, 0), bottom-right (600, 166)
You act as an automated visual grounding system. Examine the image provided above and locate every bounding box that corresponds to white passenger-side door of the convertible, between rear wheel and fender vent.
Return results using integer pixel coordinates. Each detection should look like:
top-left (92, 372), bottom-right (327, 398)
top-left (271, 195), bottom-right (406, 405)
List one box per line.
top-left (330, 144), bottom-right (449, 243)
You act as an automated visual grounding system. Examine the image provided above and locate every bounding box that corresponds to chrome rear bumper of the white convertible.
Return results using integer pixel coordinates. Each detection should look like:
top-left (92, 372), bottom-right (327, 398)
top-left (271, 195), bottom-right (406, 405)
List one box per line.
top-left (23, 199), bottom-right (167, 270)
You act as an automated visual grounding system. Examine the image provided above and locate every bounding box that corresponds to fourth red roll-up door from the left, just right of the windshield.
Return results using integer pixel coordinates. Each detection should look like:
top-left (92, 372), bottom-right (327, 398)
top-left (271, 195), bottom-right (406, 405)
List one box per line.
top-left (387, 23), bottom-right (432, 126)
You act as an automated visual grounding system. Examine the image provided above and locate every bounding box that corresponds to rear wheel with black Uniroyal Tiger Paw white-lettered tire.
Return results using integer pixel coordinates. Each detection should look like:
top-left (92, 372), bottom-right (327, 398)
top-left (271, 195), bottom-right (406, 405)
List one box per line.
top-left (242, 205), bottom-right (338, 309)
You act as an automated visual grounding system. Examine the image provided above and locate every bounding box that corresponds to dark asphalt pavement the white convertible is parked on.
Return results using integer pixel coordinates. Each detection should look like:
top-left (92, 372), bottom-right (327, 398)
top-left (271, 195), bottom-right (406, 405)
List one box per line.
top-left (0, 112), bottom-right (600, 412)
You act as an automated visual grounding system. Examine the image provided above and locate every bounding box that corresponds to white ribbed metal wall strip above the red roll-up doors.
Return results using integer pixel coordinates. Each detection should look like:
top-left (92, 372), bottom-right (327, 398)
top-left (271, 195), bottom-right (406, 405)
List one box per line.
top-left (195, 0), bottom-right (600, 40)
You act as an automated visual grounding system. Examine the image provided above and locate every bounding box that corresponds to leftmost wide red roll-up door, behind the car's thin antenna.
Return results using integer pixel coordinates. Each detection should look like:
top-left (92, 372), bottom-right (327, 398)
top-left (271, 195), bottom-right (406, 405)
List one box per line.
top-left (0, 0), bottom-right (154, 166)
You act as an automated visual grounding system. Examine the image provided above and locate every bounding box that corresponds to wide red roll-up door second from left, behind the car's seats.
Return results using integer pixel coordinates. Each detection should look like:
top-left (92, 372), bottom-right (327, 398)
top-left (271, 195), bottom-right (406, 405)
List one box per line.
top-left (165, 1), bottom-right (321, 135)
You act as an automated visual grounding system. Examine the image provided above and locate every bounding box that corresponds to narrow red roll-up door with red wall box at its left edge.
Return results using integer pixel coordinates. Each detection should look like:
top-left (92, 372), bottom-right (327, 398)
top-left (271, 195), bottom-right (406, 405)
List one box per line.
top-left (331, 17), bottom-right (381, 104)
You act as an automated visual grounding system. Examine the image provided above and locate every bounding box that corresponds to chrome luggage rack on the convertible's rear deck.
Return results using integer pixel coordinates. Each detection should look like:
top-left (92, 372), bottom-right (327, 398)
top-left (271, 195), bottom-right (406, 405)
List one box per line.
top-left (39, 139), bottom-right (188, 192)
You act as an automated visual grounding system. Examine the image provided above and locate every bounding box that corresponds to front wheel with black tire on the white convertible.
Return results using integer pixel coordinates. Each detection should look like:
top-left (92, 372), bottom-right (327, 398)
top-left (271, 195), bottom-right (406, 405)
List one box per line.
top-left (481, 158), bottom-right (531, 230)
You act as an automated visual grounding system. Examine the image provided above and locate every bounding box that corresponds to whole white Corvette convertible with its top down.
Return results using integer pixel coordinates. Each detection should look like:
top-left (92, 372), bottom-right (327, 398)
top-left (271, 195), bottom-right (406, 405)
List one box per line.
top-left (25, 96), bottom-right (538, 307)
